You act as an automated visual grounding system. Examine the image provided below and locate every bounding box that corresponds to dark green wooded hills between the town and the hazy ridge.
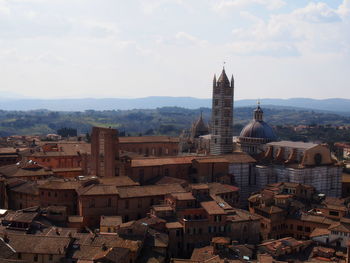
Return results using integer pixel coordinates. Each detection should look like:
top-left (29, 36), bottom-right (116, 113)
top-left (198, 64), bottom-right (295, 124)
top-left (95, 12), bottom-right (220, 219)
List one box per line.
top-left (0, 106), bottom-right (350, 141)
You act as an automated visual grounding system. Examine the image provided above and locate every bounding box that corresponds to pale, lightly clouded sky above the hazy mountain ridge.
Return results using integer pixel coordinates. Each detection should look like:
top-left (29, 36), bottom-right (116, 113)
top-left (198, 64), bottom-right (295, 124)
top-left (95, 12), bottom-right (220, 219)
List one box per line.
top-left (0, 0), bottom-right (350, 99)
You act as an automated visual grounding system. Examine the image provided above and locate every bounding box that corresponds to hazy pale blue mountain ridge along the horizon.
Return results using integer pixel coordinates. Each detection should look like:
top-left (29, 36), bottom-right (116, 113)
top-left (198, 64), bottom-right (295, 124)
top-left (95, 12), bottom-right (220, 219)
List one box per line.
top-left (0, 96), bottom-right (350, 114)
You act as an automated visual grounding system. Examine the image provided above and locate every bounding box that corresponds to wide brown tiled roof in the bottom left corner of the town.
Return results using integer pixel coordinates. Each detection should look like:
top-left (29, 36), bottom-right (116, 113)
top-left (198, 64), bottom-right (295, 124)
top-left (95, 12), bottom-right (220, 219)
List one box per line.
top-left (8, 234), bottom-right (71, 255)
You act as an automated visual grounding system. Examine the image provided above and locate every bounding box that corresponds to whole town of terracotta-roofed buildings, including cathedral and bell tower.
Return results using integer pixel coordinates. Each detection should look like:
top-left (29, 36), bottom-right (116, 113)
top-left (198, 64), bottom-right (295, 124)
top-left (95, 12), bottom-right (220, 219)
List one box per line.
top-left (0, 69), bottom-right (350, 263)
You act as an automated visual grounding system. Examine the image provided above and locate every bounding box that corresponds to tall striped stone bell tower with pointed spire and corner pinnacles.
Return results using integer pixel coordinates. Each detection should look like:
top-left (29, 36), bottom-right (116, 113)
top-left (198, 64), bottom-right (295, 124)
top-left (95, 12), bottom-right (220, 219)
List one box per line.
top-left (210, 68), bottom-right (234, 155)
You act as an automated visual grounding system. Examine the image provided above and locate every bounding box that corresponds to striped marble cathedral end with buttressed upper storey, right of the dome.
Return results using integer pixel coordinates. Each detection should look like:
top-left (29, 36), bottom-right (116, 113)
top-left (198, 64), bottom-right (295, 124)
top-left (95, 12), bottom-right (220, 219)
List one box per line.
top-left (256, 141), bottom-right (342, 197)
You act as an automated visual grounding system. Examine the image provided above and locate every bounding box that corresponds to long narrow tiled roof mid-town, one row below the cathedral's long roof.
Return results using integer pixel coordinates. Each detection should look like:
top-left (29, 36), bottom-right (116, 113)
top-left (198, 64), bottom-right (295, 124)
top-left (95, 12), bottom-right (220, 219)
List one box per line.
top-left (117, 184), bottom-right (185, 198)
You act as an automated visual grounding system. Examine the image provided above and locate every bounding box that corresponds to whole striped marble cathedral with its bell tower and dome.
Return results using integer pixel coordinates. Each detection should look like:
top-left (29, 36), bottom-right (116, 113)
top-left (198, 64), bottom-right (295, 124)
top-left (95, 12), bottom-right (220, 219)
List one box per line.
top-left (180, 69), bottom-right (342, 200)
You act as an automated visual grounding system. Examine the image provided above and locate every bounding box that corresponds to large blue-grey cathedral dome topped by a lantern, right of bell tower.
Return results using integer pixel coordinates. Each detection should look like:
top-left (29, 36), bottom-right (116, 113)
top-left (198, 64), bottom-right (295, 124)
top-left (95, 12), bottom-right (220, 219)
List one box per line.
top-left (240, 105), bottom-right (277, 141)
